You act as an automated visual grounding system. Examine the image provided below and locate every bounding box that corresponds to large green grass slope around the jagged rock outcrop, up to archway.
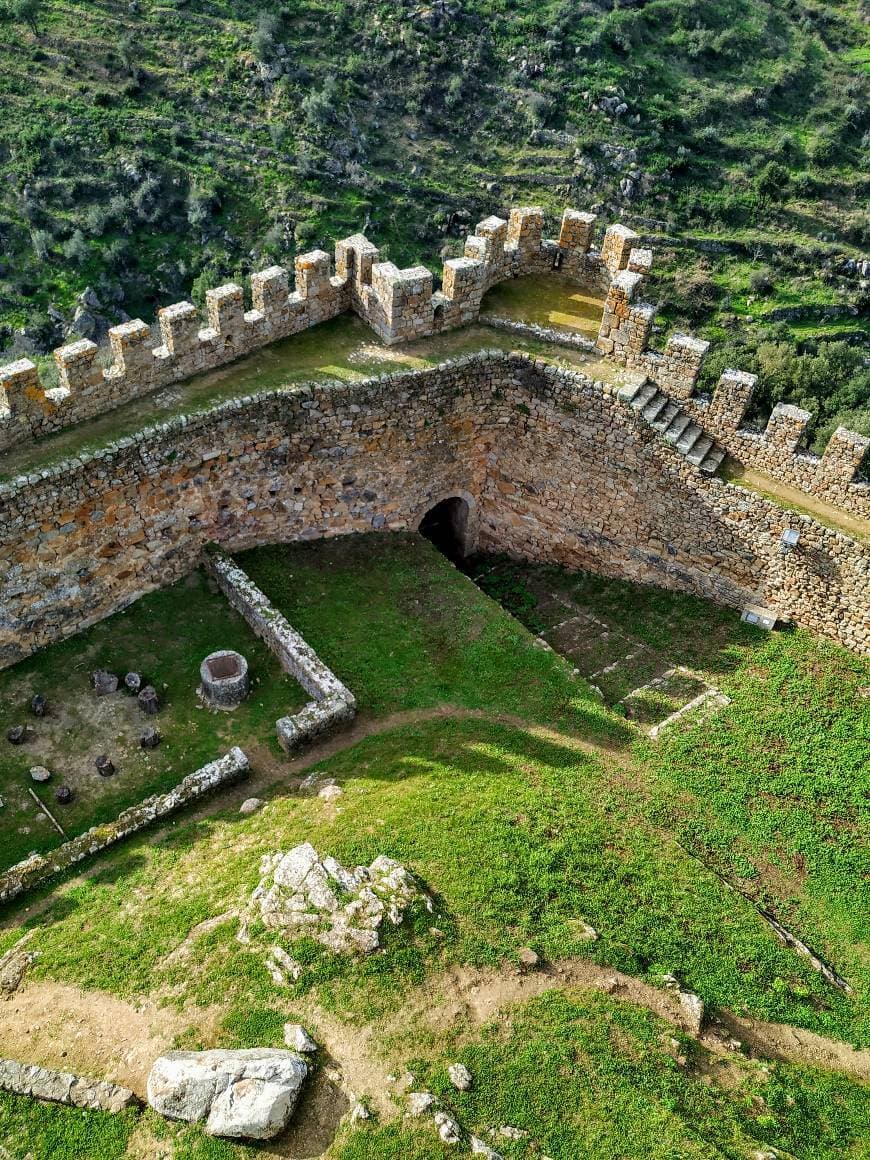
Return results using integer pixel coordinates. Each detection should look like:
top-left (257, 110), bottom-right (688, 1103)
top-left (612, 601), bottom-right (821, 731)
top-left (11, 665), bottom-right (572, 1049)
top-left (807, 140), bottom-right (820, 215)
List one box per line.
top-left (0, 536), bottom-right (869, 1160)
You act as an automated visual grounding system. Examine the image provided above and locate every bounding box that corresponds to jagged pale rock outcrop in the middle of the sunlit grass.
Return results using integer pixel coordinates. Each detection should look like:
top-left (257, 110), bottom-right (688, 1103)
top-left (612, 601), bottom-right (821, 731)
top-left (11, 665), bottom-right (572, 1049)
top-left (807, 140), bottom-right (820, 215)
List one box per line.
top-left (245, 842), bottom-right (434, 966)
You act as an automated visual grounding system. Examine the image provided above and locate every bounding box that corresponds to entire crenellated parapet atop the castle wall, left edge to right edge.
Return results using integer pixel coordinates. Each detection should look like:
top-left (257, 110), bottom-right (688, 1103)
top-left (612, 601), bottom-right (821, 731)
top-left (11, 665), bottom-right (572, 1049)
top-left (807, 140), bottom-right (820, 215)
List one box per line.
top-left (0, 206), bottom-right (870, 547)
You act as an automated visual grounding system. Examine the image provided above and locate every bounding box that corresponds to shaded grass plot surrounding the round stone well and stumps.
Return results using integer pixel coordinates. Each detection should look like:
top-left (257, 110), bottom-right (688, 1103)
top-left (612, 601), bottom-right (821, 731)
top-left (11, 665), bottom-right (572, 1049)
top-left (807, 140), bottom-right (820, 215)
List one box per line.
top-left (0, 572), bottom-right (307, 867)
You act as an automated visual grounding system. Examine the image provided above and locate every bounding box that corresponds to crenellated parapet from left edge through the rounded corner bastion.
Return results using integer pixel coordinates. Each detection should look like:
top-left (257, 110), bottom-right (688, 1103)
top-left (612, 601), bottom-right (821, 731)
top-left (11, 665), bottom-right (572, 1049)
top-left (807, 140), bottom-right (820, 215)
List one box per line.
top-left (0, 208), bottom-right (631, 451)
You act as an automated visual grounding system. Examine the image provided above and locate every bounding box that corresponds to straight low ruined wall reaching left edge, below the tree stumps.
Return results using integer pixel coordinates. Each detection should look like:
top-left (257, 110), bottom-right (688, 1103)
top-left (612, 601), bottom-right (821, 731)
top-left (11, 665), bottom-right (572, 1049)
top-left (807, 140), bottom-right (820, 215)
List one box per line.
top-left (0, 747), bottom-right (248, 904)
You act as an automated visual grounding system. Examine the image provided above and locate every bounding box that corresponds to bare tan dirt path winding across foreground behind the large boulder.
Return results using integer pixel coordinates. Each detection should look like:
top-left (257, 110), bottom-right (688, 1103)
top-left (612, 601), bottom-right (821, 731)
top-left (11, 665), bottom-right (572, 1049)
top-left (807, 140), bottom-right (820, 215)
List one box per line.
top-left (0, 958), bottom-right (870, 1119)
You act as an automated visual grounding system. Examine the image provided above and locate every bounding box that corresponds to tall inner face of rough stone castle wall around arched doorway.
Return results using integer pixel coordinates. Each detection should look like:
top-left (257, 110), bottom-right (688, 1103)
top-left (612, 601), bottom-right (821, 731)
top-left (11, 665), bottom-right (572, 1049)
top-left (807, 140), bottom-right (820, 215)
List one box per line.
top-left (0, 351), bottom-right (870, 665)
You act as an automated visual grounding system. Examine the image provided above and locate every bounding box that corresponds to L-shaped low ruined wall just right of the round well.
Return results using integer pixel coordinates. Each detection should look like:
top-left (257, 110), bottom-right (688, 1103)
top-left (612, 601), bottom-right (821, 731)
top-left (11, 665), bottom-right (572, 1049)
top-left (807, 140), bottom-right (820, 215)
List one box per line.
top-left (203, 549), bottom-right (356, 753)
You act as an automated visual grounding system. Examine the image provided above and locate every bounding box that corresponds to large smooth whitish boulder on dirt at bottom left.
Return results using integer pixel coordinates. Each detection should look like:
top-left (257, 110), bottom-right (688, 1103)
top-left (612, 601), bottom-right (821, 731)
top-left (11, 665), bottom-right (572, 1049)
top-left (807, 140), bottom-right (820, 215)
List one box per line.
top-left (147, 1047), bottom-right (309, 1140)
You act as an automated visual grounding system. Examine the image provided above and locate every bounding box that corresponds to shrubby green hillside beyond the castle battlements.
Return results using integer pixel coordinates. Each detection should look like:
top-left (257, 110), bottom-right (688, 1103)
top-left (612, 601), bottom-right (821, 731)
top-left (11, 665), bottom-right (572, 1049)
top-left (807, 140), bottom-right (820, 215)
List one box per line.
top-left (0, 0), bottom-right (870, 431)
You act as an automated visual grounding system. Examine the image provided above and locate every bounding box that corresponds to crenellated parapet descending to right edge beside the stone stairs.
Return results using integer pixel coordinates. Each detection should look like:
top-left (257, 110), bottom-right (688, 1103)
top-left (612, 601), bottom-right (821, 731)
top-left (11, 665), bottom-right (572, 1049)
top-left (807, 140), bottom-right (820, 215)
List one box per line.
top-left (597, 273), bottom-right (870, 519)
